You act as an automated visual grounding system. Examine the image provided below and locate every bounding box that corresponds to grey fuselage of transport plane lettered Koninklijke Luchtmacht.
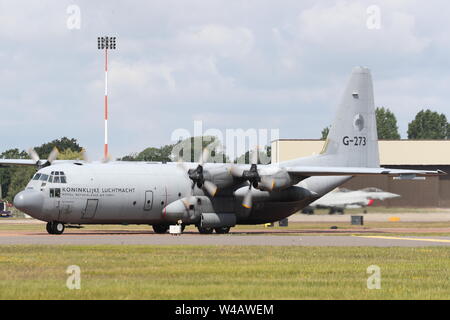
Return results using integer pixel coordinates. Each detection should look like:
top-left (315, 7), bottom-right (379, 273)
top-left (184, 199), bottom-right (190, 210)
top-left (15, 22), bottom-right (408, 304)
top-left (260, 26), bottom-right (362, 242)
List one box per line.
top-left (15, 162), bottom-right (348, 225)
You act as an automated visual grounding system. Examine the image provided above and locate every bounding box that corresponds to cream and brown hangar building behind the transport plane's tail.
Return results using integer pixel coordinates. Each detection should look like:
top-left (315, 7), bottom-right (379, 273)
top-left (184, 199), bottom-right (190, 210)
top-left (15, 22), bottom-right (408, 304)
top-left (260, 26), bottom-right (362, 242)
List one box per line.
top-left (272, 139), bottom-right (450, 208)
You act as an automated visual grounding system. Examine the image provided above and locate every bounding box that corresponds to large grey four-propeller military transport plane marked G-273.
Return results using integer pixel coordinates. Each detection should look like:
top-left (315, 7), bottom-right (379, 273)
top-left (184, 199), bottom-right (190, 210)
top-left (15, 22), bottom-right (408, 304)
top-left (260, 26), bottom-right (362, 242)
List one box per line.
top-left (0, 67), bottom-right (445, 234)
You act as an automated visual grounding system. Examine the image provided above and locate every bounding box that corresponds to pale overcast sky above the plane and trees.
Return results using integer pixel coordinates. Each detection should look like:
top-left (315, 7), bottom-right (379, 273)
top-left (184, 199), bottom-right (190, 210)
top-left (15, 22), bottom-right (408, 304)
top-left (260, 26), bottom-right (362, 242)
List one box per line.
top-left (0, 0), bottom-right (450, 159)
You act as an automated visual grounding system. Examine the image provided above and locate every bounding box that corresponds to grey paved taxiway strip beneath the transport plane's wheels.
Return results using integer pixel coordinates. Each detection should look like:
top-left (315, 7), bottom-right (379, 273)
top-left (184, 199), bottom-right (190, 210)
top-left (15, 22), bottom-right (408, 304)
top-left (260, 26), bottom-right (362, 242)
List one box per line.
top-left (0, 231), bottom-right (450, 247)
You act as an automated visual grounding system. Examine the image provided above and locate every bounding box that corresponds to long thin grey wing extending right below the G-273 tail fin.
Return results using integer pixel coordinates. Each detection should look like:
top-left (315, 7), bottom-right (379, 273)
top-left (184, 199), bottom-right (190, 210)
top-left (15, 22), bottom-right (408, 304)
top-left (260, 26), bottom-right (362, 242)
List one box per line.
top-left (286, 167), bottom-right (447, 179)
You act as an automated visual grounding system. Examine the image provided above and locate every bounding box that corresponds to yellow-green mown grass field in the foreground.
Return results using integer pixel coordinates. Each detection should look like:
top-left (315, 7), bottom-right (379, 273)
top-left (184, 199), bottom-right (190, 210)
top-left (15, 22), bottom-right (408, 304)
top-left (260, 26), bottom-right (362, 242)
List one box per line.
top-left (0, 246), bottom-right (450, 299)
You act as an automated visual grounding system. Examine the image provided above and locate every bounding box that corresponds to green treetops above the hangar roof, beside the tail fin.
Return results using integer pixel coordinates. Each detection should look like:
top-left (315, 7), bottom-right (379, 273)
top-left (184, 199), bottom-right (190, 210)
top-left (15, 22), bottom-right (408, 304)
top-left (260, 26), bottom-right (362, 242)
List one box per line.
top-left (322, 107), bottom-right (450, 140)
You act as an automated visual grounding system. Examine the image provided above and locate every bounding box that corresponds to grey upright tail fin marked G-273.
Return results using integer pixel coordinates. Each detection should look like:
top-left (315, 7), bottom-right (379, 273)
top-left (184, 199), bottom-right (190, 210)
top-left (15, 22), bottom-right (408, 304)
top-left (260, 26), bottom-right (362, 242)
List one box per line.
top-left (319, 67), bottom-right (380, 168)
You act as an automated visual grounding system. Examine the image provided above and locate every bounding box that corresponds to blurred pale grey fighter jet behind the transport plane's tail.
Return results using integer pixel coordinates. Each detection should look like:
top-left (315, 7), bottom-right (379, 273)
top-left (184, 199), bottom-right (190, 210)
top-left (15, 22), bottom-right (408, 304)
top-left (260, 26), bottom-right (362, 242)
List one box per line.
top-left (302, 187), bottom-right (400, 214)
